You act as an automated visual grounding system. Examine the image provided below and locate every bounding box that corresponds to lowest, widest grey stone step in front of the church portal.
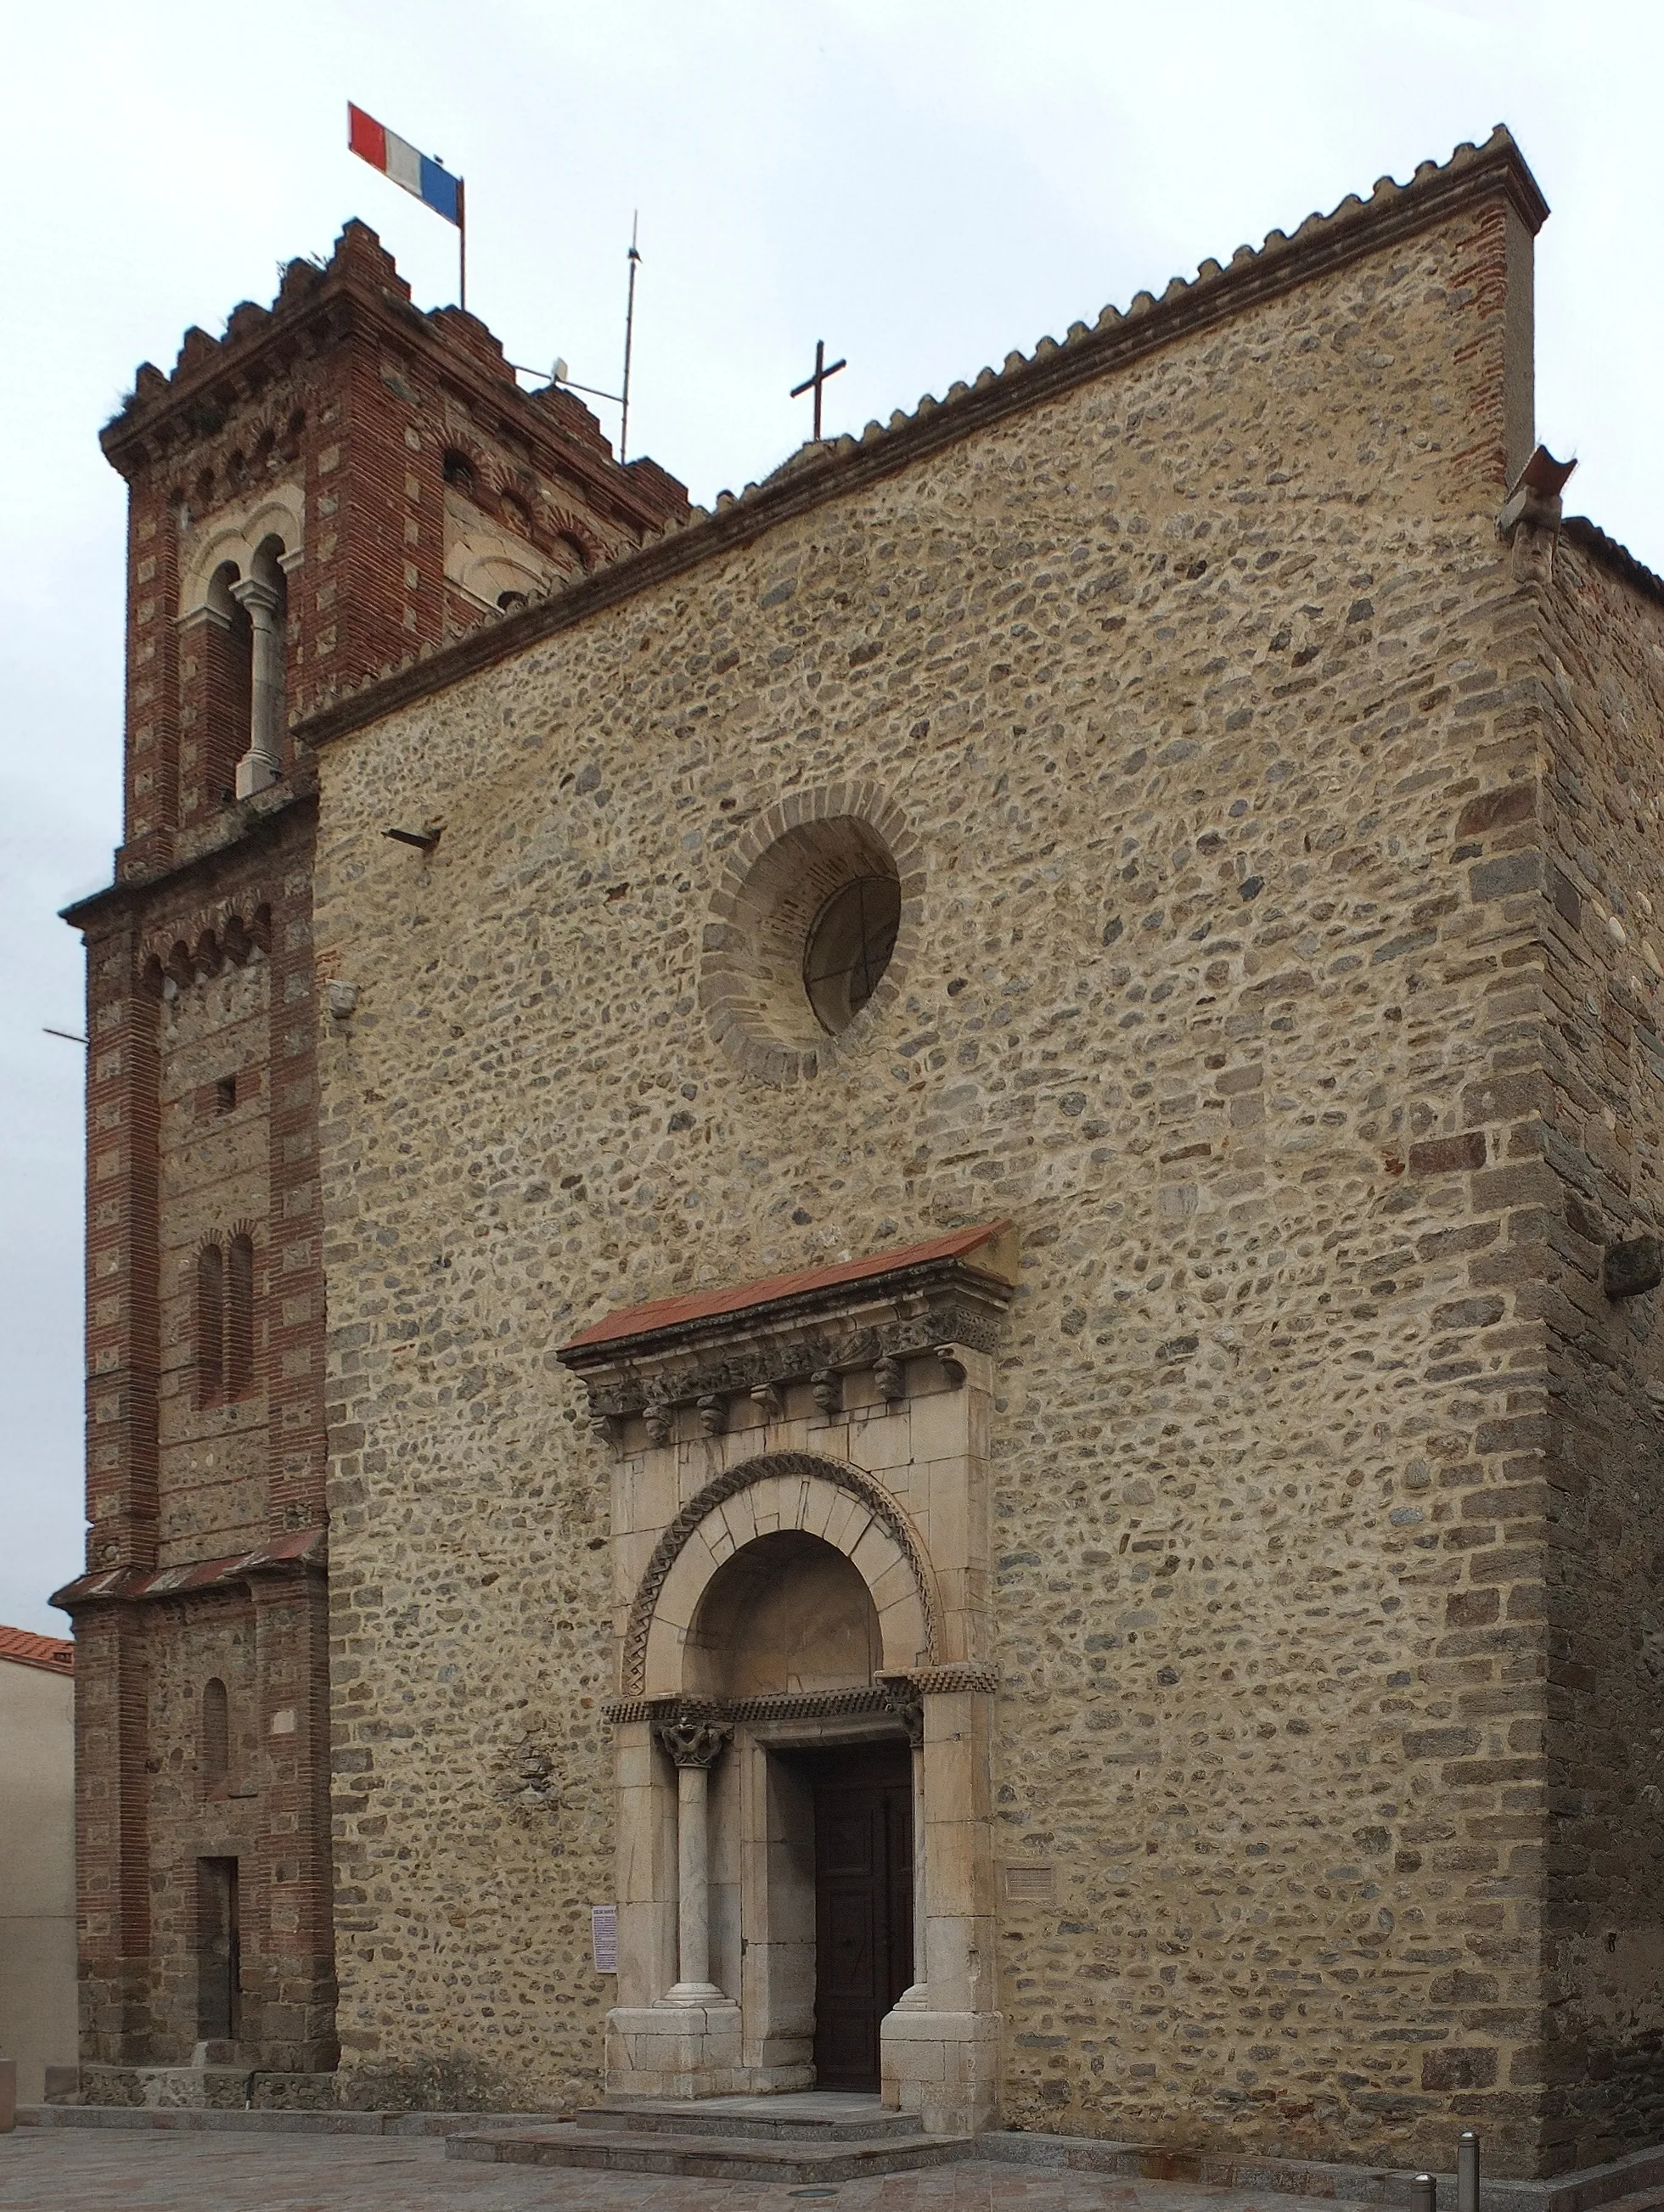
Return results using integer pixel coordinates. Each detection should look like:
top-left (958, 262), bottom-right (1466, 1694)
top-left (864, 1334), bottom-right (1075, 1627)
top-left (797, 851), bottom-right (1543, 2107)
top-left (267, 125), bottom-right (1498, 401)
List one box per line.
top-left (455, 2114), bottom-right (975, 2183)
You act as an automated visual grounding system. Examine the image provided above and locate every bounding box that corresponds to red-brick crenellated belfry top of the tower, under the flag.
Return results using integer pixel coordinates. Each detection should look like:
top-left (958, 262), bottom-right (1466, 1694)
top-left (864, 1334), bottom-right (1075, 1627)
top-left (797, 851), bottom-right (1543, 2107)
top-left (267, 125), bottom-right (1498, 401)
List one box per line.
top-left (102, 222), bottom-right (689, 876)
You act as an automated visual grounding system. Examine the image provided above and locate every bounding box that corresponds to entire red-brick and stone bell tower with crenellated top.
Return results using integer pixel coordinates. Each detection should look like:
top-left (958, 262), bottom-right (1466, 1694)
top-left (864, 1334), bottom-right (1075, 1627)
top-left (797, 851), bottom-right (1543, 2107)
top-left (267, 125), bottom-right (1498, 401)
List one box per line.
top-left (58, 222), bottom-right (686, 2103)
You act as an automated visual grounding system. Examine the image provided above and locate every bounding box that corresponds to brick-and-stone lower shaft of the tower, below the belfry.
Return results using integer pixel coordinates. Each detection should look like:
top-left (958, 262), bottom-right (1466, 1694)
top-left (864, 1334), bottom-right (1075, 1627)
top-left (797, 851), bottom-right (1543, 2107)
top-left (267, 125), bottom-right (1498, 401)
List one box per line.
top-left (59, 792), bottom-right (334, 2095)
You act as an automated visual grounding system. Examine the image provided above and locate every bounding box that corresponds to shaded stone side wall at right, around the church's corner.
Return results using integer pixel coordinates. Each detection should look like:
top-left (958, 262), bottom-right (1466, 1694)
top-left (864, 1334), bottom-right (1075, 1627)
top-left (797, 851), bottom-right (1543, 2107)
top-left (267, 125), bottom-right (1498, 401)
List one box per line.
top-left (1509, 525), bottom-right (1664, 2161)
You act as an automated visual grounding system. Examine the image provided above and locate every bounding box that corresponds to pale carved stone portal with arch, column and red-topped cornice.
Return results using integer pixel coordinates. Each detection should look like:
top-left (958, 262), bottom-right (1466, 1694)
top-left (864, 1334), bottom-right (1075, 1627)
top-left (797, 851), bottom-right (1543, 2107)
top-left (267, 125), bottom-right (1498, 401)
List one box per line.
top-left (562, 1226), bottom-right (1015, 2135)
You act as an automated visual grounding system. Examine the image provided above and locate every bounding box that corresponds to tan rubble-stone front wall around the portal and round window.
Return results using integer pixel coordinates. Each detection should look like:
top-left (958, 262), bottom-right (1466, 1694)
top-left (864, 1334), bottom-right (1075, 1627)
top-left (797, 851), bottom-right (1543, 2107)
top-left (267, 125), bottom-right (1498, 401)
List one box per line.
top-left (303, 147), bottom-right (1602, 2170)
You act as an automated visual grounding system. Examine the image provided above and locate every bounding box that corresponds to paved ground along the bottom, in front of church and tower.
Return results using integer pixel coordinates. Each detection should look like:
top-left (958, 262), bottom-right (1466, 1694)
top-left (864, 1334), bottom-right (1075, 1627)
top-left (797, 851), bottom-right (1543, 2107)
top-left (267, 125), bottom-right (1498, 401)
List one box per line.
top-left (0, 2128), bottom-right (1290, 2212)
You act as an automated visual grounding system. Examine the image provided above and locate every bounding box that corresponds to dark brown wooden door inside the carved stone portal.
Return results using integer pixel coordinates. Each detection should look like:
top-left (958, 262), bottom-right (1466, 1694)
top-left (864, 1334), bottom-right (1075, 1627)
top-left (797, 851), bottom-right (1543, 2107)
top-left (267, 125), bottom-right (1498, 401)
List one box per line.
top-left (812, 1743), bottom-right (914, 2091)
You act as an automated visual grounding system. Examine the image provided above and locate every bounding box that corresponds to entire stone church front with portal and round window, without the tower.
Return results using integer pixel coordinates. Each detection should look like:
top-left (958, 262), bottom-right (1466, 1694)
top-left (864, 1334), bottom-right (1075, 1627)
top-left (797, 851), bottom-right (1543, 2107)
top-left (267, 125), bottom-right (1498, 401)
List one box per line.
top-left (69, 132), bottom-right (1664, 2175)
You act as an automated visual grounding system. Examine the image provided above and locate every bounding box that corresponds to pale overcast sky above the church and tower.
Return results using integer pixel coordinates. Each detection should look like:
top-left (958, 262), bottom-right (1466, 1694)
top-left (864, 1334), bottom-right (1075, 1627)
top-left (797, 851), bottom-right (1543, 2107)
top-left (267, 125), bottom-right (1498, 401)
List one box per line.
top-left (0, 0), bottom-right (1664, 1632)
